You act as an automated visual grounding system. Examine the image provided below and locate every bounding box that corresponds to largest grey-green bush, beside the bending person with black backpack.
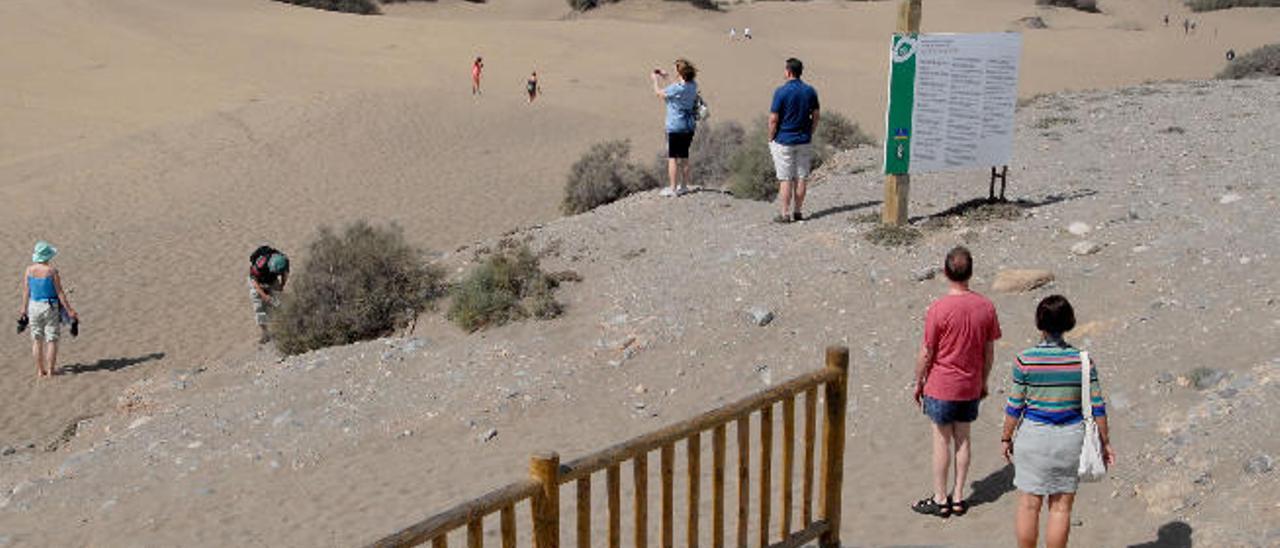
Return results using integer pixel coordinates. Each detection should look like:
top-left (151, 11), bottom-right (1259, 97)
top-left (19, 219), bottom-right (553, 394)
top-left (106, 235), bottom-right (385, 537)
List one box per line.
top-left (269, 222), bottom-right (443, 355)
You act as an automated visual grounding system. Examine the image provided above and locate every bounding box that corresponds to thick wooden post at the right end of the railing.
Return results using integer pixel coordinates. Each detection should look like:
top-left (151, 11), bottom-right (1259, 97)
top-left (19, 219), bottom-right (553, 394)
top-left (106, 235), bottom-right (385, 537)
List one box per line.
top-left (818, 346), bottom-right (849, 548)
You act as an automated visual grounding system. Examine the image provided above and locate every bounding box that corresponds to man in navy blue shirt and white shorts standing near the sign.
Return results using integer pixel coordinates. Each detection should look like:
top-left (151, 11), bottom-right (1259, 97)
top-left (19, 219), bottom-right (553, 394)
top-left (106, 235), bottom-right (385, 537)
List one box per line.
top-left (769, 58), bottom-right (818, 223)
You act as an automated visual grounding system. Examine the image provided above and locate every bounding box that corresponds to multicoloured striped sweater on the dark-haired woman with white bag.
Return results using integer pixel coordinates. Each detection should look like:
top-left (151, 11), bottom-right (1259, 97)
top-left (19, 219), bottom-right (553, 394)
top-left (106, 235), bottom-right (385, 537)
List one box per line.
top-left (1005, 342), bottom-right (1107, 425)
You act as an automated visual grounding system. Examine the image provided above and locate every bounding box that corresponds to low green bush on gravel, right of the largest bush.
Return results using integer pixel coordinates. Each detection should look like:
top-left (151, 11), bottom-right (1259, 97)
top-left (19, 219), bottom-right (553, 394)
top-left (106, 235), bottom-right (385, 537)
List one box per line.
top-left (448, 246), bottom-right (563, 332)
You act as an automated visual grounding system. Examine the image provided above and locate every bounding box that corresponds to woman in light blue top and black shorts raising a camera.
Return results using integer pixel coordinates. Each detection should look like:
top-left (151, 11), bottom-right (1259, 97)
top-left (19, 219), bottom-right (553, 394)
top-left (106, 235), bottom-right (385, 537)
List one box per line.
top-left (650, 59), bottom-right (698, 197)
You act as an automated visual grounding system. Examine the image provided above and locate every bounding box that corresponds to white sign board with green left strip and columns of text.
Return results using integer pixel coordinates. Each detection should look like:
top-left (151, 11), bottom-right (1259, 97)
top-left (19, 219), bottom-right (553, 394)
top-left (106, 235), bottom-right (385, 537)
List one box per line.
top-left (884, 32), bottom-right (1023, 173)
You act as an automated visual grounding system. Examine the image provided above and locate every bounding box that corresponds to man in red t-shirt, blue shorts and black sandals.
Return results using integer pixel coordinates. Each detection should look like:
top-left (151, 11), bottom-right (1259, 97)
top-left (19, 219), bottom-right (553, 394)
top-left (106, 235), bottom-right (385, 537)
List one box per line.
top-left (911, 247), bottom-right (1000, 517)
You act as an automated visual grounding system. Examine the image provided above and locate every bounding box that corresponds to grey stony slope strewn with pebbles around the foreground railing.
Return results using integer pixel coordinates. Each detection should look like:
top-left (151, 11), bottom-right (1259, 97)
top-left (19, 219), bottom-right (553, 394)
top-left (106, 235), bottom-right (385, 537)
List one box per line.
top-left (0, 75), bottom-right (1280, 548)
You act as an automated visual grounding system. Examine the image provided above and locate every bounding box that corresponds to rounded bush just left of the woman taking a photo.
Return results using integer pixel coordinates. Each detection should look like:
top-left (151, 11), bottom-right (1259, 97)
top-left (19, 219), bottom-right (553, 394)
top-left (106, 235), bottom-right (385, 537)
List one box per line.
top-left (561, 141), bottom-right (659, 215)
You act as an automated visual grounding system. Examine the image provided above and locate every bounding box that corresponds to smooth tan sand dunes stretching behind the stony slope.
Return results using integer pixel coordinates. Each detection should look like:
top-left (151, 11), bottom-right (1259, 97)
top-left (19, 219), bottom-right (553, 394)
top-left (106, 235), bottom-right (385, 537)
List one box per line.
top-left (0, 0), bottom-right (1280, 543)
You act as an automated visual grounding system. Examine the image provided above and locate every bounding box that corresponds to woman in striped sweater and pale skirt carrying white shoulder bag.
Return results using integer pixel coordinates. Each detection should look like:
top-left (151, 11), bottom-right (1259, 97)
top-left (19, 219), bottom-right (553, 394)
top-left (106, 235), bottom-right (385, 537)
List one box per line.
top-left (1000, 294), bottom-right (1116, 548)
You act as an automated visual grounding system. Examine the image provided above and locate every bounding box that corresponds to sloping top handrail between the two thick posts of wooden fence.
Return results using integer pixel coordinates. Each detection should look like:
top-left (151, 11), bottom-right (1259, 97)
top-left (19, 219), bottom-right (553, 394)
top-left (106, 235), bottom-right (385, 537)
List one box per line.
top-left (561, 369), bottom-right (842, 484)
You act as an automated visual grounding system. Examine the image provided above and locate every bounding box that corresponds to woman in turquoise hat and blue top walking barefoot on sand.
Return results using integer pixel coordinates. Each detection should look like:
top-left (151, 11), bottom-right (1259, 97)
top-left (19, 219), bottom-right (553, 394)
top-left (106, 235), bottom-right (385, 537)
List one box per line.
top-left (18, 241), bottom-right (79, 378)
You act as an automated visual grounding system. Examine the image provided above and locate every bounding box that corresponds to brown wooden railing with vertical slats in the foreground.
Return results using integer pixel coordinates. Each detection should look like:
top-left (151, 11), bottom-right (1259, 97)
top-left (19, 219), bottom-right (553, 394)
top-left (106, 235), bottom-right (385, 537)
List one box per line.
top-left (370, 347), bottom-right (849, 548)
